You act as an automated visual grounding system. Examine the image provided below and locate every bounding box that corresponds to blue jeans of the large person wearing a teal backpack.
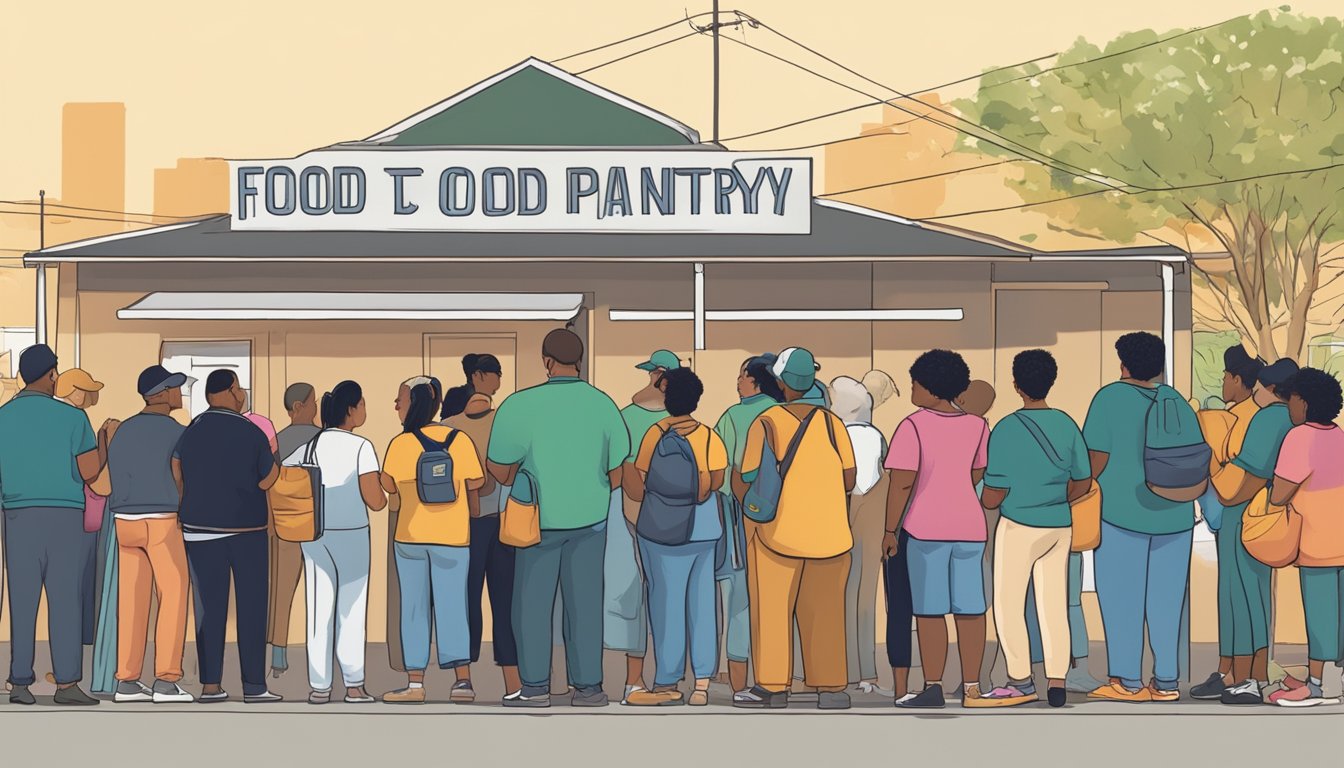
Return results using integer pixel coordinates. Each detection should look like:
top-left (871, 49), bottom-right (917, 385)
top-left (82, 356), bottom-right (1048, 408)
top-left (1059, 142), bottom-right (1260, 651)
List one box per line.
top-left (1093, 521), bottom-right (1193, 690)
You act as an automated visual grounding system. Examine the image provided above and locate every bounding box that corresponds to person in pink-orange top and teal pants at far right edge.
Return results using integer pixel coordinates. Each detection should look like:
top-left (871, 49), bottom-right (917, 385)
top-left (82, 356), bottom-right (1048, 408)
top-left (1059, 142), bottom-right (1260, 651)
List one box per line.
top-left (1269, 369), bottom-right (1344, 707)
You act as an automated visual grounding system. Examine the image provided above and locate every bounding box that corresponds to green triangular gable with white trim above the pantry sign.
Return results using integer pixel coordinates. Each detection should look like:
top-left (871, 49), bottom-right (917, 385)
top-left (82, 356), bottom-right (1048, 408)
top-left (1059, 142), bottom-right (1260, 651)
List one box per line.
top-left (367, 59), bottom-right (700, 147)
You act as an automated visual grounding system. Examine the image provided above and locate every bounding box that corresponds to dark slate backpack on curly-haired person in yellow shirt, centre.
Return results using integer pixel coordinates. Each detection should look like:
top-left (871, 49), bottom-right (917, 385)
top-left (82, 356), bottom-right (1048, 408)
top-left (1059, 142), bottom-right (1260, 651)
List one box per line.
top-left (634, 428), bottom-right (710, 546)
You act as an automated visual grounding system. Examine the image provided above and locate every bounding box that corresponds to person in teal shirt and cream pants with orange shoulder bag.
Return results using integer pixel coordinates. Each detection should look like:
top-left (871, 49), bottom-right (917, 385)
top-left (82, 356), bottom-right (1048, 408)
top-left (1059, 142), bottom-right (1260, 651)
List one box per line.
top-left (977, 350), bottom-right (1091, 707)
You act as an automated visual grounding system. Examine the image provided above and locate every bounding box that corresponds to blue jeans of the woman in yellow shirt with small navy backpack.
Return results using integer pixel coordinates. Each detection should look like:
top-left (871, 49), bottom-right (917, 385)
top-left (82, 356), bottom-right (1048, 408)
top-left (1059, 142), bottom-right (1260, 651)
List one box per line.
top-left (395, 542), bottom-right (472, 671)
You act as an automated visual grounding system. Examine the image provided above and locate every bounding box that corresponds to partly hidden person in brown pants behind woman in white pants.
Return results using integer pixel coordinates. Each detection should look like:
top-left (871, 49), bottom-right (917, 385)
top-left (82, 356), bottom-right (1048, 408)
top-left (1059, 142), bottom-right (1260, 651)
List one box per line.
top-left (266, 382), bottom-right (320, 678)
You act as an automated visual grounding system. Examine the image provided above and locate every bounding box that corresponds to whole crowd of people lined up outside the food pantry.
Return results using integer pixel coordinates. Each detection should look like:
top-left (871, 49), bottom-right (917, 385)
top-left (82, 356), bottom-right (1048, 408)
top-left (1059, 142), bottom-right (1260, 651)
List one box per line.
top-left (0, 330), bottom-right (1344, 709)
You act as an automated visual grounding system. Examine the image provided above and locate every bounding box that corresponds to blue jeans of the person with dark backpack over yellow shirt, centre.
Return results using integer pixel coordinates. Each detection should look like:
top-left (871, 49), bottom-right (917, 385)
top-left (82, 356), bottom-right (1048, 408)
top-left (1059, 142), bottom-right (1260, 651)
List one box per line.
top-left (638, 538), bottom-right (719, 686)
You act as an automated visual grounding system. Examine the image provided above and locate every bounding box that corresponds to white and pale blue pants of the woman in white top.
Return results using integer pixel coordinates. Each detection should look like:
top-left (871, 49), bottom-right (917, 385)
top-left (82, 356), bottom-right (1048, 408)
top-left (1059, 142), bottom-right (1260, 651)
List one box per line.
top-left (302, 527), bottom-right (370, 691)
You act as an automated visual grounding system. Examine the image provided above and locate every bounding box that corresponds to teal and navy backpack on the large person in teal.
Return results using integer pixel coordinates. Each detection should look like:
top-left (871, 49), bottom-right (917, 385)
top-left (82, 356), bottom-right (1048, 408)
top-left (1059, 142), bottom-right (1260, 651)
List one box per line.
top-left (1144, 385), bottom-right (1214, 502)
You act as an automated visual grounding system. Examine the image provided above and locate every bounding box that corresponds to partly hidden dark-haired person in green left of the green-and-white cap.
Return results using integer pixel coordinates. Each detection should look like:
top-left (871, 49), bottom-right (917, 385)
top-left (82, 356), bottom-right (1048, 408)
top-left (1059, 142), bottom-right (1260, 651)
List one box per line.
top-left (714, 352), bottom-right (784, 694)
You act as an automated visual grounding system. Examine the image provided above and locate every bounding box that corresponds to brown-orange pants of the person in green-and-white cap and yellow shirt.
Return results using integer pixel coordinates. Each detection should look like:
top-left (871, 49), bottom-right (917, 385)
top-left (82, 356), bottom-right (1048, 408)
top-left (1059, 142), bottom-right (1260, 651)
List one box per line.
top-left (747, 531), bottom-right (849, 691)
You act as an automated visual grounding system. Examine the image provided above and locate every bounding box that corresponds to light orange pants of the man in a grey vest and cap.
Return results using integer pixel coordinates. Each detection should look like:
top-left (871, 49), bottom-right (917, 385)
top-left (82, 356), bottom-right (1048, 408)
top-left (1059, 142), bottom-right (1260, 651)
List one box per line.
top-left (117, 518), bottom-right (190, 682)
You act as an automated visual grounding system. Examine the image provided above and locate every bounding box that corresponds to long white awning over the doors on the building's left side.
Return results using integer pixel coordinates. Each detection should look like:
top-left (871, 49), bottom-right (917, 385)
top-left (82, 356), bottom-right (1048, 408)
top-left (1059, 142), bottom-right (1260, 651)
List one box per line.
top-left (117, 292), bottom-right (583, 321)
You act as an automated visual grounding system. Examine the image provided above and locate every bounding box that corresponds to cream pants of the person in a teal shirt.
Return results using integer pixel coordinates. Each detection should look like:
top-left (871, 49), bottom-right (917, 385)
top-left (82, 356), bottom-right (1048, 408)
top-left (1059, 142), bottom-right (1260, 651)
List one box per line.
top-left (995, 518), bottom-right (1073, 682)
